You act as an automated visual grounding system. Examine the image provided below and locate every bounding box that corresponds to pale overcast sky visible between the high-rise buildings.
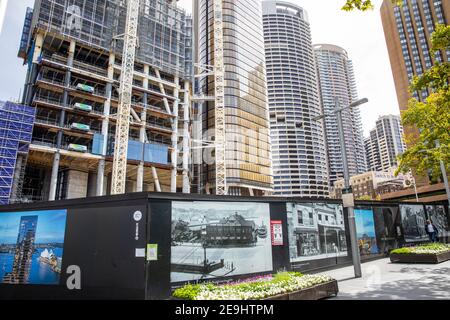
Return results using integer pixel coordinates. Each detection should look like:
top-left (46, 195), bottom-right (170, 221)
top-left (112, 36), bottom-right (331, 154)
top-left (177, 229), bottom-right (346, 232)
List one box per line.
top-left (0, 0), bottom-right (399, 136)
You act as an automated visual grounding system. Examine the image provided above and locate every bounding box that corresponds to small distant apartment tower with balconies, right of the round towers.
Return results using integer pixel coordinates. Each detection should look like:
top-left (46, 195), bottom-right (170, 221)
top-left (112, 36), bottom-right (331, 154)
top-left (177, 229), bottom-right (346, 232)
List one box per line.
top-left (366, 115), bottom-right (406, 172)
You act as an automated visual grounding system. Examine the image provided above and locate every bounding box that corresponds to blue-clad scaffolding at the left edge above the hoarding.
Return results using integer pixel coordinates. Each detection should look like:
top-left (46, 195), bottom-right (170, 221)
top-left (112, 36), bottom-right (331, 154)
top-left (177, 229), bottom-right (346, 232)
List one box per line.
top-left (0, 101), bottom-right (36, 205)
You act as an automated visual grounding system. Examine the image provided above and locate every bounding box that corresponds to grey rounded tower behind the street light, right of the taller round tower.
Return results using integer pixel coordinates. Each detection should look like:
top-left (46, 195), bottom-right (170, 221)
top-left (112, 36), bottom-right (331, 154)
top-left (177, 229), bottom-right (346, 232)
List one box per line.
top-left (314, 44), bottom-right (367, 186)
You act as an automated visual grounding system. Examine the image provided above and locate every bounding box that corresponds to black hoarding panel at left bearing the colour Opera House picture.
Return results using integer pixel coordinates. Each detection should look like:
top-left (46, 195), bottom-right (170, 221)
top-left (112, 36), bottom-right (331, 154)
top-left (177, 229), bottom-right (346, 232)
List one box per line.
top-left (0, 197), bottom-right (147, 299)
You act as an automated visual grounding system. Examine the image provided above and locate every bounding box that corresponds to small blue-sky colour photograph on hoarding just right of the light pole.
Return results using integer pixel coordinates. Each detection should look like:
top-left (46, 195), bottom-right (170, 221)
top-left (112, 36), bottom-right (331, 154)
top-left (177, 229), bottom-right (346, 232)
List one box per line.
top-left (355, 209), bottom-right (379, 256)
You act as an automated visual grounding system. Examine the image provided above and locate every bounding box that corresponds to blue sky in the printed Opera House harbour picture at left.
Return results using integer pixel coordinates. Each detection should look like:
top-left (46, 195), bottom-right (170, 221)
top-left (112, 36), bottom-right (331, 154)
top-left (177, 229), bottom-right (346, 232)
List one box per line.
top-left (0, 210), bottom-right (67, 244)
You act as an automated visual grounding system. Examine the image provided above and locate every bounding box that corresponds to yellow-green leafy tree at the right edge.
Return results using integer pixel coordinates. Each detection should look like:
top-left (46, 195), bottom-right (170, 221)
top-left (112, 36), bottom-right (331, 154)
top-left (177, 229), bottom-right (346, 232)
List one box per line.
top-left (398, 25), bottom-right (450, 181)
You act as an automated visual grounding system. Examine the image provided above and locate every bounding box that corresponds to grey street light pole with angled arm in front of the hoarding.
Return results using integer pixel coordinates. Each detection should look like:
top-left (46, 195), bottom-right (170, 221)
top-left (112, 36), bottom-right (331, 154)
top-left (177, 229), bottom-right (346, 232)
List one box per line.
top-left (314, 98), bottom-right (369, 278)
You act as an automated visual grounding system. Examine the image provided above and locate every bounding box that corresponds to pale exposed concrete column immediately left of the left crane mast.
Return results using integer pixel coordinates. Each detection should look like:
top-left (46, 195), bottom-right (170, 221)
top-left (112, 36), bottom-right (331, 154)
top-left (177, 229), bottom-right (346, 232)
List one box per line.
top-left (97, 53), bottom-right (116, 197)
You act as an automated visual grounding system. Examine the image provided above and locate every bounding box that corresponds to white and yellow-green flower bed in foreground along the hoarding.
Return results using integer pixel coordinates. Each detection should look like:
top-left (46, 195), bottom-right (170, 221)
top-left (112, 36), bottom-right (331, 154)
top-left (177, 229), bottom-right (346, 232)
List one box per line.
top-left (173, 272), bottom-right (337, 300)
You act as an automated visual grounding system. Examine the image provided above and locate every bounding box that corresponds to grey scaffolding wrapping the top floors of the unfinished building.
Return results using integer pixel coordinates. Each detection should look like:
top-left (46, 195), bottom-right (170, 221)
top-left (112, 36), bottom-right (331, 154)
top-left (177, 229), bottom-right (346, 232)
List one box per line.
top-left (28, 0), bottom-right (191, 78)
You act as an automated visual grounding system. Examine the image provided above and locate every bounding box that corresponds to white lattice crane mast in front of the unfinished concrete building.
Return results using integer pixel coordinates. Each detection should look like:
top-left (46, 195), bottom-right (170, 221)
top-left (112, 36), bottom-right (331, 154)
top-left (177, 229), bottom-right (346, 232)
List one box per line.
top-left (111, 0), bottom-right (140, 195)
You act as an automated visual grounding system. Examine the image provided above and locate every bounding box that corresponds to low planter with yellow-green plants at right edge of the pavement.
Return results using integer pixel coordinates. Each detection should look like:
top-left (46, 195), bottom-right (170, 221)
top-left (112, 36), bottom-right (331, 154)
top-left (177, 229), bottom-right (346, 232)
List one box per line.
top-left (390, 243), bottom-right (450, 264)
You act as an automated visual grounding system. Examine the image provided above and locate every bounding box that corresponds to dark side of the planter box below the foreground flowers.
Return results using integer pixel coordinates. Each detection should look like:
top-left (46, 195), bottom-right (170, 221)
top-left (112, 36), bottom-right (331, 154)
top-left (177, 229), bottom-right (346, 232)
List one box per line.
top-left (265, 280), bottom-right (339, 301)
